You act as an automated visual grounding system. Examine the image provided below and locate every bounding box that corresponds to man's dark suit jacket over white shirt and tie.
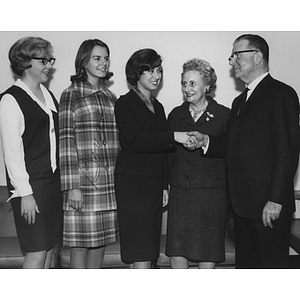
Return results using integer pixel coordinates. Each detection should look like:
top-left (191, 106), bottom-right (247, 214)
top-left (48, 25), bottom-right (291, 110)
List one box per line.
top-left (207, 75), bottom-right (300, 218)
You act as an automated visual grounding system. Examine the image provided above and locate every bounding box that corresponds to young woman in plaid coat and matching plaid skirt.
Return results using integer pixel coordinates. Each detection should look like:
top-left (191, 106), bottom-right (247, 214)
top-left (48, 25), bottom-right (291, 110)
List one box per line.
top-left (59, 39), bottom-right (120, 269)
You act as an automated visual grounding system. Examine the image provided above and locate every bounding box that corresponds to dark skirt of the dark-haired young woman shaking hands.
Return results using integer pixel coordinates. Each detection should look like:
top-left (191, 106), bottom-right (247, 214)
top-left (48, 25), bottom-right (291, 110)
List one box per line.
top-left (115, 174), bottom-right (163, 263)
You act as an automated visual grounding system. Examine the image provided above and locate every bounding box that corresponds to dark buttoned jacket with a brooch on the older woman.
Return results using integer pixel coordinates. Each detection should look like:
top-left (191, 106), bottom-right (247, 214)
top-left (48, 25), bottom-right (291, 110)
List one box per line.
top-left (168, 97), bottom-right (230, 189)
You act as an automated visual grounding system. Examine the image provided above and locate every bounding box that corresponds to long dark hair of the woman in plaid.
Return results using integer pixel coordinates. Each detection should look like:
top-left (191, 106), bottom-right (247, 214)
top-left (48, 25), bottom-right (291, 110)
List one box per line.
top-left (71, 39), bottom-right (113, 82)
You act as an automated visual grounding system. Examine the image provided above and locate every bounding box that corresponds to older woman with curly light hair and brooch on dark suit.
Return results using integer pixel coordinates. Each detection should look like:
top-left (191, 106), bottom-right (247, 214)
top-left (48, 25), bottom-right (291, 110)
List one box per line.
top-left (166, 59), bottom-right (229, 268)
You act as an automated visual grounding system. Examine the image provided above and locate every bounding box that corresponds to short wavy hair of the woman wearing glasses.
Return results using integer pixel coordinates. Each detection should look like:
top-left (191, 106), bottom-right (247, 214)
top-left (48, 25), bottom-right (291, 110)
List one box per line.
top-left (8, 36), bottom-right (53, 76)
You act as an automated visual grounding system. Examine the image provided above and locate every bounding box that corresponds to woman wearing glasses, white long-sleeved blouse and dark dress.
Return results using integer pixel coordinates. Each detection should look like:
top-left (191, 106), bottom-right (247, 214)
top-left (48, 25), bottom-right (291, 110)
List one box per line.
top-left (0, 37), bottom-right (62, 268)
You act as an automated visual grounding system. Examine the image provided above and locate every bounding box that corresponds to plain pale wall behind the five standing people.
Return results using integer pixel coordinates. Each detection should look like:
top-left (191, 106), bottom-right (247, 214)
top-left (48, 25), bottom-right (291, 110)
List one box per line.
top-left (0, 31), bottom-right (300, 188)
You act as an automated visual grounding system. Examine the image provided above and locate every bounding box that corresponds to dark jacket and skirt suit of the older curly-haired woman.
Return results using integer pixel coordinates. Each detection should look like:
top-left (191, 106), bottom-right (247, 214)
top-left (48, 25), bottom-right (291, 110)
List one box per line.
top-left (166, 97), bottom-right (230, 262)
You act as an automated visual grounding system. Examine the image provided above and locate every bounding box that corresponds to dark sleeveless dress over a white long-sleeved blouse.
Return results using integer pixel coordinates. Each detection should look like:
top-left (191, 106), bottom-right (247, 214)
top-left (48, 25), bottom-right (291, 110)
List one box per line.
top-left (3, 86), bottom-right (62, 252)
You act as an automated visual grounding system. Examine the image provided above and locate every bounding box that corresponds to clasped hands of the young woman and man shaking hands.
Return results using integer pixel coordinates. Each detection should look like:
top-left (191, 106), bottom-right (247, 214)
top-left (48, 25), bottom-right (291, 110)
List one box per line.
top-left (174, 131), bottom-right (208, 151)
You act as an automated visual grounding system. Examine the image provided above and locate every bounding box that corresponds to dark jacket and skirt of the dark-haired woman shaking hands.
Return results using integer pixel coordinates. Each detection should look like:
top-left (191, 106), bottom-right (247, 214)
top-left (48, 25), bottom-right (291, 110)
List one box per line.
top-left (115, 90), bottom-right (175, 263)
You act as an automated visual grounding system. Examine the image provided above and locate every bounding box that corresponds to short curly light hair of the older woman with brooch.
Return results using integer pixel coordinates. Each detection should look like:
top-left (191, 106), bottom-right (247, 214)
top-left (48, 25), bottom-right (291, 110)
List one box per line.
top-left (181, 58), bottom-right (217, 94)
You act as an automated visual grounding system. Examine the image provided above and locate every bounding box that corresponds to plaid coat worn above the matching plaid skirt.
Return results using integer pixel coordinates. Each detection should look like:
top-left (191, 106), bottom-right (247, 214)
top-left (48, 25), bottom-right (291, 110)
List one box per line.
top-left (59, 81), bottom-right (120, 212)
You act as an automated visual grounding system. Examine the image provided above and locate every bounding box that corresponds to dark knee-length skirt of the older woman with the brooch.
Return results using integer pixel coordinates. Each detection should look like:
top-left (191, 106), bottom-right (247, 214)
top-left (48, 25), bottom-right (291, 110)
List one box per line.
top-left (166, 186), bottom-right (227, 262)
